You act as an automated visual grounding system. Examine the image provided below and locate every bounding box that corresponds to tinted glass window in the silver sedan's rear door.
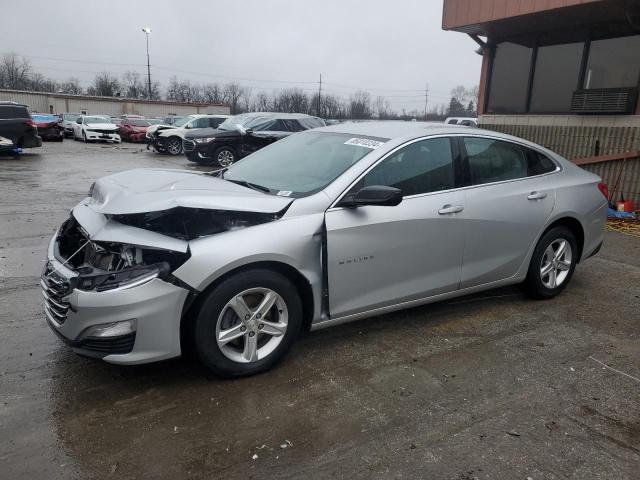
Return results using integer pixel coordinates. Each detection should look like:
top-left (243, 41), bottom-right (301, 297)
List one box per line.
top-left (462, 137), bottom-right (528, 185)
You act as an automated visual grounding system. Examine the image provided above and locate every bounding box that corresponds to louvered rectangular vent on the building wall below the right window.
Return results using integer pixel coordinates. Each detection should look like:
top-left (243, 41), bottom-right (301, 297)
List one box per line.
top-left (571, 88), bottom-right (638, 114)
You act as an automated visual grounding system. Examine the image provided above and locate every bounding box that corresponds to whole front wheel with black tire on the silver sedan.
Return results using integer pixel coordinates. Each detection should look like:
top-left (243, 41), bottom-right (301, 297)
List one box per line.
top-left (192, 269), bottom-right (302, 378)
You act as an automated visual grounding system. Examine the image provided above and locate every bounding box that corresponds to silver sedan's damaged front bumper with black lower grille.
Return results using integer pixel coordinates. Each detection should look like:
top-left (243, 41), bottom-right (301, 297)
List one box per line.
top-left (41, 233), bottom-right (188, 365)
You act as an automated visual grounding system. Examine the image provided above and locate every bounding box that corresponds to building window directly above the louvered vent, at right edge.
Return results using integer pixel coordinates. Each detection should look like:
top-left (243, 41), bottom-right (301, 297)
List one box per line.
top-left (584, 35), bottom-right (640, 89)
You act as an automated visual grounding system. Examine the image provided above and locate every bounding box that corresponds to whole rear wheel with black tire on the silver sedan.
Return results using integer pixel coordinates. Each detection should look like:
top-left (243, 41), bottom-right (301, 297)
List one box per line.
top-left (522, 226), bottom-right (578, 300)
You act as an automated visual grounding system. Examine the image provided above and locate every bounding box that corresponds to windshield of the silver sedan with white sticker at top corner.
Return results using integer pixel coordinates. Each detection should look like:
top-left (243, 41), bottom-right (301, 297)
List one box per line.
top-left (223, 131), bottom-right (387, 197)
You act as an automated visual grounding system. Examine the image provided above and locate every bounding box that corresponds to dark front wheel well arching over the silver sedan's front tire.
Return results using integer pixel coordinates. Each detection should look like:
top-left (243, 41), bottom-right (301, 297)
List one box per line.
top-left (180, 262), bottom-right (314, 352)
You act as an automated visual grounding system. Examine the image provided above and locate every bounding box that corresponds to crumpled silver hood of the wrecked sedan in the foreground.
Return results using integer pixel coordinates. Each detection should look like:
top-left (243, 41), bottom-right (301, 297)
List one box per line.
top-left (86, 168), bottom-right (292, 215)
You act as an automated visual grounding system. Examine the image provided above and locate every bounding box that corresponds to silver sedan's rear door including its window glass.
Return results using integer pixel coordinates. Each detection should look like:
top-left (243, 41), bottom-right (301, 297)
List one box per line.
top-left (459, 136), bottom-right (557, 288)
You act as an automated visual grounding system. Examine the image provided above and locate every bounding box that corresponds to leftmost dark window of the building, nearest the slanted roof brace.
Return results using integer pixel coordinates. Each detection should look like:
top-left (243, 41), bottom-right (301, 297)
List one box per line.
top-left (488, 42), bottom-right (533, 113)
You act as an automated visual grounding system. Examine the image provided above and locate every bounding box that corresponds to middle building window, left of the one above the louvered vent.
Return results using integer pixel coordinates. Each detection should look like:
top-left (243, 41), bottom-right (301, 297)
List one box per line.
top-left (529, 43), bottom-right (584, 113)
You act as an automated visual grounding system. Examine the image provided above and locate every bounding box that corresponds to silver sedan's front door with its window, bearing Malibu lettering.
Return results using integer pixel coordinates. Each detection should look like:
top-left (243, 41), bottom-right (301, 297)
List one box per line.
top-left (325, 138), bottom-right (464, 318)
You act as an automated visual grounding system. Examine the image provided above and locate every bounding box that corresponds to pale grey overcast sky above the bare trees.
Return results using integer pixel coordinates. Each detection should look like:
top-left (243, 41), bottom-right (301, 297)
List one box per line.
top-left (0, 0), bottom-right (481, 111)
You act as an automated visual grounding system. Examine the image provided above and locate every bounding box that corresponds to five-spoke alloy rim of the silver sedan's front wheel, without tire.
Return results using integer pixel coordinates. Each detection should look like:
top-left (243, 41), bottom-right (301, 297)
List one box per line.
top-left (216, 288), bottom-right (289, 363)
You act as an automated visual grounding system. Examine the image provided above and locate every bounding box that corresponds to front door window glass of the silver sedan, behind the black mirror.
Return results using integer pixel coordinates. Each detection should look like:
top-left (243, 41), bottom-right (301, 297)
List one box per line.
top-left (358, 138), bottom-right (454, 197)
